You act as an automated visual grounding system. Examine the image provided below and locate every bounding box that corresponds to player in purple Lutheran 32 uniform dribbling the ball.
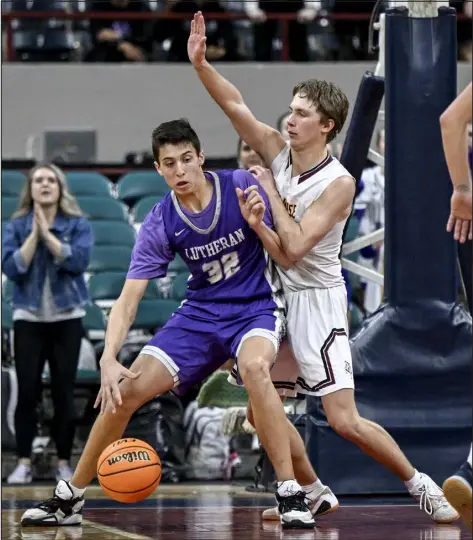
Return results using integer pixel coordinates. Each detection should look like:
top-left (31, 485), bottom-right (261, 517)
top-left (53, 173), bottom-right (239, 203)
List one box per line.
top-left (21, 119), bottom-right (315, 528)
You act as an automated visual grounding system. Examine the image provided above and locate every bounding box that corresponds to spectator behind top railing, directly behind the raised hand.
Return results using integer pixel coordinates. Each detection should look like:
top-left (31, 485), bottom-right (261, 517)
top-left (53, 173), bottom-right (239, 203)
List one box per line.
top-left (155, 0), bottom-right (239, 62)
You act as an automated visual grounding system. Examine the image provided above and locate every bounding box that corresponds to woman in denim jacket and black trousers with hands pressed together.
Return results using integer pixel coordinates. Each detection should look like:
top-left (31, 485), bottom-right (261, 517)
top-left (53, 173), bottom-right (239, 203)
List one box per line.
top-left (2, 164), bottom-right (93, 484)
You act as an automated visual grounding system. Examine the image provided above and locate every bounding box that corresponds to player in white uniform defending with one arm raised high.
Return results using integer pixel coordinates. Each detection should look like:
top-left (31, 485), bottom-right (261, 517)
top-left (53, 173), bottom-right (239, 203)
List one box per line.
top-left (188, 12), bottom-right (459, 523)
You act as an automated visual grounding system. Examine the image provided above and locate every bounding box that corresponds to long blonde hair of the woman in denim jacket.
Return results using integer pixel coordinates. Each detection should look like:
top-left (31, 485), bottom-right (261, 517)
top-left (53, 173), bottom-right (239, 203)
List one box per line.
top-left (12, 163), bottom-right (84, 219)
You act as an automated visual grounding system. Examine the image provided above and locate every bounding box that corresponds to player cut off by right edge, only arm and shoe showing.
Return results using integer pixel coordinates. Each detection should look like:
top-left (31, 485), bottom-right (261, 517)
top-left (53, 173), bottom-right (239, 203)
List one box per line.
top-left (440, 83), bottom-right (473, 529)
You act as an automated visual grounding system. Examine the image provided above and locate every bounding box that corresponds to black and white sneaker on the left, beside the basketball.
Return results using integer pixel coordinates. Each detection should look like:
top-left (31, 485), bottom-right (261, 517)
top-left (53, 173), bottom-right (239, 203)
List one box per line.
top-left (21, 480), bottom-right (84, 527)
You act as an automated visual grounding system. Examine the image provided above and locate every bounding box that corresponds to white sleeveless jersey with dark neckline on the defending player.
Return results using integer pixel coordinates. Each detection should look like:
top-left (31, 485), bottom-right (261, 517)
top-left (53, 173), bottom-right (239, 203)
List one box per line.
top-left (271, 141), bottom-right (351, 292)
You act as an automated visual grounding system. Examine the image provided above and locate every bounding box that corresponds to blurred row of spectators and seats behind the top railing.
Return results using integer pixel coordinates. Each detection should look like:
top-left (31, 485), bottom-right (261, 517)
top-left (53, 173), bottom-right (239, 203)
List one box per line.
top-left (2, 0), bottom-right (472, 62)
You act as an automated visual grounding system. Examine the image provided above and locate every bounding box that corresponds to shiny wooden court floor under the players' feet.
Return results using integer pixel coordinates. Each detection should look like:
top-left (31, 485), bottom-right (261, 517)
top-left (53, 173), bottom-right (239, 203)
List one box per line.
top-left (1, 484), bottom-right (471, 540)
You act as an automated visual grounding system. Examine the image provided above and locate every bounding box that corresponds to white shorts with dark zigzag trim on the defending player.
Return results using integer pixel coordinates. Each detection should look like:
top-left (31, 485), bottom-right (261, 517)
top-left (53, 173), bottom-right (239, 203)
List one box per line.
top-left (271, 285), bottom-right (354, 397)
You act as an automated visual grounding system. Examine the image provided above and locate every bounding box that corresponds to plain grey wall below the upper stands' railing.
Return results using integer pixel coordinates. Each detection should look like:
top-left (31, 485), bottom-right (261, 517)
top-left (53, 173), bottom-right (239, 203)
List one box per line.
top-left (2, 63), bottom-right (471, 162)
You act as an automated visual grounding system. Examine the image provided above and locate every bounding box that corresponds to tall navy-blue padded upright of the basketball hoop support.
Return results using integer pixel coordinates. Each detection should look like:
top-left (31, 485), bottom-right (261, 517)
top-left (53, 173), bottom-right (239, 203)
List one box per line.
top-left (385, 8), bottom-right (457, 306)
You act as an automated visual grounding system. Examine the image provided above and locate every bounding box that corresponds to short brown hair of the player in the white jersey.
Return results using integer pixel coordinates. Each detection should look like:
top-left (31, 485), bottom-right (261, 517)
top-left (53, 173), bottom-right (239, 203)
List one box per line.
top-left (292, 79), bottom-right (349, 143)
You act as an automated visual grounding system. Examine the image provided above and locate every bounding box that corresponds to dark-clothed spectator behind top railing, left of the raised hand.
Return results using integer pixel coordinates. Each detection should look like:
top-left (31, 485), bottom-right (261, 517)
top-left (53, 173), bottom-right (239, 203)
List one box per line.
top-left (85, 0), bottom-right (153, 62)
